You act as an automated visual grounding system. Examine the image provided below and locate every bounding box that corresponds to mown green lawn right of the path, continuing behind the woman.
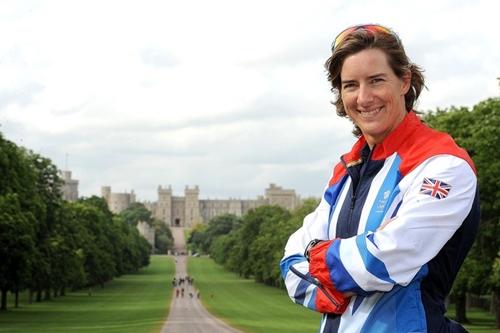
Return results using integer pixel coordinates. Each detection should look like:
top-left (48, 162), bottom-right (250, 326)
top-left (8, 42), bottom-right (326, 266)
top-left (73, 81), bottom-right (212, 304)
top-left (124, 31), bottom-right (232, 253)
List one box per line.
top-left (188, 257), bottom-right (500, 333)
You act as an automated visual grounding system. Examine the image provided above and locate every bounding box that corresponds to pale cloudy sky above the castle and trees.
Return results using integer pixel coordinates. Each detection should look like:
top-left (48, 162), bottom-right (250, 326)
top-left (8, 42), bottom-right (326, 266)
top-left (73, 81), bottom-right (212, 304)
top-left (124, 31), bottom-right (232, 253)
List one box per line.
top-left (0, 0), bottom-right (500, 201)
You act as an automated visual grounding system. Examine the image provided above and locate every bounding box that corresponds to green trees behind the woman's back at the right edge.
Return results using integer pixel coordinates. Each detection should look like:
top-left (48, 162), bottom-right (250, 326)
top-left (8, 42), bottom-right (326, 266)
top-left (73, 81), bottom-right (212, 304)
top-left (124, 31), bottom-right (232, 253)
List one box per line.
top-left (424, 98), bottom-right (500, 323)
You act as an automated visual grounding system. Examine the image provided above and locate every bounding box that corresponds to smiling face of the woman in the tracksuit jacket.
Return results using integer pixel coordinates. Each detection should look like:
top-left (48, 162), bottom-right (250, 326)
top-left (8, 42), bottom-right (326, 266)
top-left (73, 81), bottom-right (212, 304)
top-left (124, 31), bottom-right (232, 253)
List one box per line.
top-left (340, 49), bottom-right (410, 147)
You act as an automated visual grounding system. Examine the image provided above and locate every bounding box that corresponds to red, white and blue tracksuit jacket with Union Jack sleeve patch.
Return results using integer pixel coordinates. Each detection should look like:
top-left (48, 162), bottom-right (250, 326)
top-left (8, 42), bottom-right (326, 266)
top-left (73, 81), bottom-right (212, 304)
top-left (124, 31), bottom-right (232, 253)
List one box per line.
top-left (280, 111), bottom-right (479, 333)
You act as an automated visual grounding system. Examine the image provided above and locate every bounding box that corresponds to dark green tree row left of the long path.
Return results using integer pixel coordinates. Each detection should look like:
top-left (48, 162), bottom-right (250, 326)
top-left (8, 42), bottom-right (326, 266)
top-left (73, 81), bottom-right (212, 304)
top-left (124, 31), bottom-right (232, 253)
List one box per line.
top-left (0, 133), bottom-right (151, 310)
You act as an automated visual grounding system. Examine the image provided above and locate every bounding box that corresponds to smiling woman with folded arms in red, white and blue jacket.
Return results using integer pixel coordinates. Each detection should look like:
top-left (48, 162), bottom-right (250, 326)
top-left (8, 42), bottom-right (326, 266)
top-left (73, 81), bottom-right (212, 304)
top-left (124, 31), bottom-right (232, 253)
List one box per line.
top-left (281, 25), bottom-right (479, 333)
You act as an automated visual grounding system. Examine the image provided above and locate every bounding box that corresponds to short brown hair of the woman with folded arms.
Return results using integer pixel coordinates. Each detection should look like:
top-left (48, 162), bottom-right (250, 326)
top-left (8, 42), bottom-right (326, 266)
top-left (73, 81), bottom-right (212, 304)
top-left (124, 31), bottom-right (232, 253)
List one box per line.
top-left (325, 26), bottom-right (425, 136)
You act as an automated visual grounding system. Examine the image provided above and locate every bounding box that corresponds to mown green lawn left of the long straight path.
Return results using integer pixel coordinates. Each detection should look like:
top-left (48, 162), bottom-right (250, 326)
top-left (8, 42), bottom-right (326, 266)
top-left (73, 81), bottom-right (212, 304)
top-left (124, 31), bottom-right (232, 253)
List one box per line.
top-left (0, 256), bottom-right (175, 333)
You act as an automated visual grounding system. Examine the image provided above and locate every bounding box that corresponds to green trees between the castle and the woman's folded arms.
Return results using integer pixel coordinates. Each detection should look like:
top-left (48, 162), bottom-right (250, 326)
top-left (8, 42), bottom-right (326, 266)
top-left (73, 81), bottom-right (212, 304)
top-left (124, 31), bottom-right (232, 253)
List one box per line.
top-left (188, 199), bottom-right (319, 288)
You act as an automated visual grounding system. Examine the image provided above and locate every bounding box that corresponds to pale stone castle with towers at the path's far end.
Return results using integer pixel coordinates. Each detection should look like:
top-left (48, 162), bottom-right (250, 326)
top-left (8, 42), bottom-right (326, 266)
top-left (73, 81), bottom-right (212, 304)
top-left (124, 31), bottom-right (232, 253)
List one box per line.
top-left (101, 184), bottom-right (300, 227)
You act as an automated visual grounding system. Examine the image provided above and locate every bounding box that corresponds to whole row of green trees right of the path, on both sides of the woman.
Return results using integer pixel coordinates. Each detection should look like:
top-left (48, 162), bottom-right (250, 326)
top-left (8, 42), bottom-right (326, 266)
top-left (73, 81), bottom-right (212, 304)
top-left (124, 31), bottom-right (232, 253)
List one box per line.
top-left (188, 98), bottom-right (500, 327)
